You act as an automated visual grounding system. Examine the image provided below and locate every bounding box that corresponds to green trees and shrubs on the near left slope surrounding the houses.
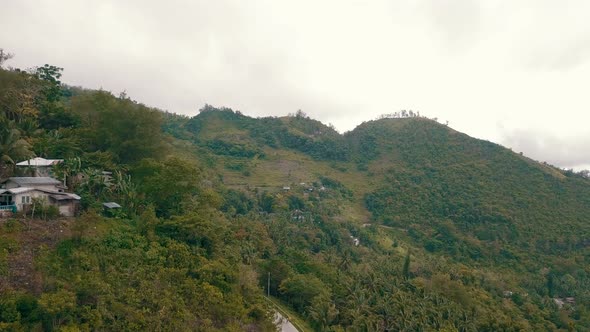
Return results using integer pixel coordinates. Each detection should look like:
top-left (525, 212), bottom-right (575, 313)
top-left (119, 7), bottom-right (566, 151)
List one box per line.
top-left (0, 59), bottom-right (274, 331)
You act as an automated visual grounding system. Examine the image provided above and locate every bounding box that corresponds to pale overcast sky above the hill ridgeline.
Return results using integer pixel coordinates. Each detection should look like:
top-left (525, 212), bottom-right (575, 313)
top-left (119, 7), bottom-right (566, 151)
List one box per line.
top-left (0, 0), bottom-right (590, 170)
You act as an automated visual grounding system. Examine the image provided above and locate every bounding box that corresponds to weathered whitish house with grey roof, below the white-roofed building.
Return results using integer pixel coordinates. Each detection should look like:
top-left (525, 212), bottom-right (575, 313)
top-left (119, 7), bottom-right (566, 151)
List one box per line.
top-left (0, 177), bottom-right (80, 217)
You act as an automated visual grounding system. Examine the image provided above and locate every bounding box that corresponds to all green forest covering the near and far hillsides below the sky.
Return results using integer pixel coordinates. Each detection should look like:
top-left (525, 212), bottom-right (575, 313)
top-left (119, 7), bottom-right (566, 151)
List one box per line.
top-left (0, 53), bottom-right (590, 331)
